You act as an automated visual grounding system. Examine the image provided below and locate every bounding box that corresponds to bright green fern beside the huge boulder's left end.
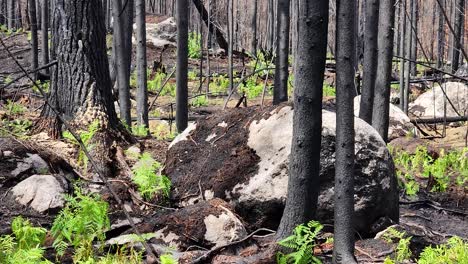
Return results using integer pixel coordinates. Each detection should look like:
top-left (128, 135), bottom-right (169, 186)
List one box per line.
top-left (132, 152), bottom-right (171, 200)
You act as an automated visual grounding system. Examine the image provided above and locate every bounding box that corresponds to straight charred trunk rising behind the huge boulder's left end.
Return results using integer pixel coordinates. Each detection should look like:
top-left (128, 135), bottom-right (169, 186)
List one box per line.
top-left (176, 0), bottom-right (189, 132)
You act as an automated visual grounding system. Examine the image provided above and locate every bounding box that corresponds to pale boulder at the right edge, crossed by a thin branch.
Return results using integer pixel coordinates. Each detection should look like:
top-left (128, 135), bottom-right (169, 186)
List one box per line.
top-left (408, 82), bottom-right (468, 117)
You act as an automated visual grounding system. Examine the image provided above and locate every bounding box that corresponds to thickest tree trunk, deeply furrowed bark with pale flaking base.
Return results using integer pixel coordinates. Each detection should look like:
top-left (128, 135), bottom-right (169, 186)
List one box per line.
top-left (36, 0), bottom-right (128, 173)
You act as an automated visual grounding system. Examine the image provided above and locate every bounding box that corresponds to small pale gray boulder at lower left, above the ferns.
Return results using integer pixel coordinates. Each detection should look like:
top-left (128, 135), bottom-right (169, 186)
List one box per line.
top-left (11, 175), bottom-right (68, 213)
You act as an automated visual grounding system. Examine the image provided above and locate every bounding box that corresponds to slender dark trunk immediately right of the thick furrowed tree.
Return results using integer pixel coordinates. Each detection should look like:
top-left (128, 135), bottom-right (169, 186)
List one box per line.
top-left (112, 0), bottom-right (132, 127)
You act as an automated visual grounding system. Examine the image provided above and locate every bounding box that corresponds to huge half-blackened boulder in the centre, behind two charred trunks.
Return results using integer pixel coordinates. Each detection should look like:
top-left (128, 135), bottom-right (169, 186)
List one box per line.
top-left (165, 106), bottom-right (398, 233)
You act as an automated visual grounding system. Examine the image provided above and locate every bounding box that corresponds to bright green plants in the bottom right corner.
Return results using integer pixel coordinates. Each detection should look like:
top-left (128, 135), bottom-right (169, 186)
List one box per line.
top-left (418, 236), bottom-right (468, 264)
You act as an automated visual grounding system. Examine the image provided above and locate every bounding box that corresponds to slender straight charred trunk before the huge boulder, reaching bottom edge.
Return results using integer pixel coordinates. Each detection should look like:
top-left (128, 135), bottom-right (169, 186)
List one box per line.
top-left (333, 0), bottom-right (356, 263)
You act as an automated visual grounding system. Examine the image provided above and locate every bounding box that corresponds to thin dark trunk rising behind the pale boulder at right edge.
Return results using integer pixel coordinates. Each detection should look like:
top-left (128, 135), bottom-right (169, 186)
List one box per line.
top-left (452, 0), bottom-right (465, 73)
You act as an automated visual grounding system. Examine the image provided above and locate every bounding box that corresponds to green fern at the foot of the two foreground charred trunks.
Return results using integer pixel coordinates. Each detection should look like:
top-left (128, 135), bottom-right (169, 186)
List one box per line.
top-left (276, 221), bottom-right (323, 264)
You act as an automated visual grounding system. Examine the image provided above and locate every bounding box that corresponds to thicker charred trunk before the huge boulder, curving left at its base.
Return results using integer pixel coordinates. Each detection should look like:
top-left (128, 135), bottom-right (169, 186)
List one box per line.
top-left (276, 0), bottom-right (328, 239)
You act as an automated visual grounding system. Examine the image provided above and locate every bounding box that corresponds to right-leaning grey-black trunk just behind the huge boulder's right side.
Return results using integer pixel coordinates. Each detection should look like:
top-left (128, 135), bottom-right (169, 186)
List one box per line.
top-left (372, 0), bottom-right (395, 142)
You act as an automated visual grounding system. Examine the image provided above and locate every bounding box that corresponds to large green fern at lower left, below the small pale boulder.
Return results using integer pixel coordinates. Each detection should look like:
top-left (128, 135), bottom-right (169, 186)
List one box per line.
top-left (51, 187), bottom-right (110, 262)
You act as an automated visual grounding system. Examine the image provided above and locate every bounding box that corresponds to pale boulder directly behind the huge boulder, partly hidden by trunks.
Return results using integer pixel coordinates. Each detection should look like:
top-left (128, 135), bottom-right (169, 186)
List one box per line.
top-left (354, 95), bottom-right (417, 140)
